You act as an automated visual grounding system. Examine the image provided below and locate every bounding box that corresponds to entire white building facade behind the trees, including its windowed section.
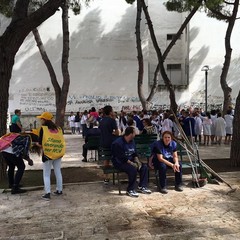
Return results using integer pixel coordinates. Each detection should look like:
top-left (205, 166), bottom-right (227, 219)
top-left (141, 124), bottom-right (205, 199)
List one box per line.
top-left (0, 0), bottom-right (240, 115)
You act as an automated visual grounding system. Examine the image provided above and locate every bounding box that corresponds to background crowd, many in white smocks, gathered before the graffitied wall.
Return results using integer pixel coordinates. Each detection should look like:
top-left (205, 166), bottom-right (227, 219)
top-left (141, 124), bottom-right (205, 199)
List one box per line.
top-left (68, 107), bottom-right (234, 146)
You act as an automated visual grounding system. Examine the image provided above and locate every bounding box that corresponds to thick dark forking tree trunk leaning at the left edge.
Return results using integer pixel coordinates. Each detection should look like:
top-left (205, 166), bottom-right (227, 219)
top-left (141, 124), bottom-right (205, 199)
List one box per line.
top-left (0, 0), bottom-right (62, 180)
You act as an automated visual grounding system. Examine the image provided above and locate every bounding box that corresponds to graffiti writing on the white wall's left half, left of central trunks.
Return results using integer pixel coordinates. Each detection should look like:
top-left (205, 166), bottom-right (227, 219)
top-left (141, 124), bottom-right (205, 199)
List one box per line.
top-left (18, 87), bottom-right (141, 113)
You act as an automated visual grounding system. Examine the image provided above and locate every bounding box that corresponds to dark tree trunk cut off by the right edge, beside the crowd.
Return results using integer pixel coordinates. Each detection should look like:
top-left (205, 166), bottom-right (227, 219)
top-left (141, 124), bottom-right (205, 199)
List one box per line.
top-left (230, 92), bottom-right (240, 167)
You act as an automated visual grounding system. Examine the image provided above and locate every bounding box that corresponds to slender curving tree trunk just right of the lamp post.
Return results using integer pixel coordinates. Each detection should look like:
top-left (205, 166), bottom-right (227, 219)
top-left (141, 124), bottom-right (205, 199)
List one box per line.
top-left (220, 0), bottom-right (239, 115)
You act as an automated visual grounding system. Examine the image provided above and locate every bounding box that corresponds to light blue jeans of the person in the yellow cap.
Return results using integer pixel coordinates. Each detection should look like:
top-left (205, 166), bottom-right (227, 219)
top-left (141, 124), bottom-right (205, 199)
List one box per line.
top-left (43, 158), bottom-right (62, 193)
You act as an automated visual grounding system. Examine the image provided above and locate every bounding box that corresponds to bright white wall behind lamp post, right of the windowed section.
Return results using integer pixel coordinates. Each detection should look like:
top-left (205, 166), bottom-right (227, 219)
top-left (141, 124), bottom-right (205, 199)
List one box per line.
top-left (188, 12), bottom-right (240, 109)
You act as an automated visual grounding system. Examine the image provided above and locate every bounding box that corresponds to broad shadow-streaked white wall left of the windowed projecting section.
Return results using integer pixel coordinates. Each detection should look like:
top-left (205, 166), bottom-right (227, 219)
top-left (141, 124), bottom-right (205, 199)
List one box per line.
top-left (9, 0), bottom-right (148, 113)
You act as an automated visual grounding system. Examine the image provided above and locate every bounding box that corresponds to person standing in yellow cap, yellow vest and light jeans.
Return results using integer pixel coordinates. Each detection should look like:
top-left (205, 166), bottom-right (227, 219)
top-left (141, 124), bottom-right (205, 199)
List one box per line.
top-left (37, 112), bottom-right (66, 201)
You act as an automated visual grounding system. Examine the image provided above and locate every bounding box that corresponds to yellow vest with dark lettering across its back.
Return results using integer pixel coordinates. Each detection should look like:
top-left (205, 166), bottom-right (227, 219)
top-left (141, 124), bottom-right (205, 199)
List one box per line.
top-left (42, 126), bottom-right (66, 160)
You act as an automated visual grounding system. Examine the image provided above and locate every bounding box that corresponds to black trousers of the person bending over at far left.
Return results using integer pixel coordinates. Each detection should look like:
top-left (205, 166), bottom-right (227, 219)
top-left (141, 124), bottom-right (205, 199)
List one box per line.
top-left (2, 152), bottom-right (25, 188)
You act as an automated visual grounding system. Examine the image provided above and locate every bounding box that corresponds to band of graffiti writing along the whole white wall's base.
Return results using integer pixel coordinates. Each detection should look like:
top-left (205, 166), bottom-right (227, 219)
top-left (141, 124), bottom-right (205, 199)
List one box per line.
top-left (14, 87), bottom-right (231, 113)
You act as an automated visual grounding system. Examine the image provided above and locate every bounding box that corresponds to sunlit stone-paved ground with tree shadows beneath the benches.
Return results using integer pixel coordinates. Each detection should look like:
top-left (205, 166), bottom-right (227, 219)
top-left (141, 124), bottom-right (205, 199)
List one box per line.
top-left (0, 135), bottom-right (240, 240)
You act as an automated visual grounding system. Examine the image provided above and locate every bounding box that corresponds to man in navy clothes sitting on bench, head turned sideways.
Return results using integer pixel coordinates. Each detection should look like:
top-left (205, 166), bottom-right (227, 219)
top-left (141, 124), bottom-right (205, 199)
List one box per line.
top-left (111, 127), bottom-right (151, 197)
